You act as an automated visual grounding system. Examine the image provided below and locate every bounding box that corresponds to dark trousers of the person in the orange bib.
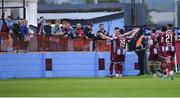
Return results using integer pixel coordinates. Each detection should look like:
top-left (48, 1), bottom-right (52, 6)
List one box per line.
top-left (136, 49), bottom-right (146, 75)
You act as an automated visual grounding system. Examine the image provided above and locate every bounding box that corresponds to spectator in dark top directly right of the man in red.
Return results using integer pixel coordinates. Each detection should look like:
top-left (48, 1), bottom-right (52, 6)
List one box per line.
top-left (84, 23), bottom-right (94, 38)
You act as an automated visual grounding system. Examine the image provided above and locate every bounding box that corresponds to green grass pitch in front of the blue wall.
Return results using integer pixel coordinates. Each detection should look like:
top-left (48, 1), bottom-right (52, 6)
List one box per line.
top-left (0, 74), bottom-right (180, 97)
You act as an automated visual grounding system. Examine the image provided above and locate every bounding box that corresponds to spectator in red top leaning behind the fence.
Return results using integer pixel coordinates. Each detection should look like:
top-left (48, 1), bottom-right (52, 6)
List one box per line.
top-left (74, 23), bottom-right (84, 37)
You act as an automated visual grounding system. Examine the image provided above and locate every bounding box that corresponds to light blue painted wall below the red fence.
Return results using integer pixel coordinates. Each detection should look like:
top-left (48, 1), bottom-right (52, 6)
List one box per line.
top-left (0, 52), bottom-right (139, 79)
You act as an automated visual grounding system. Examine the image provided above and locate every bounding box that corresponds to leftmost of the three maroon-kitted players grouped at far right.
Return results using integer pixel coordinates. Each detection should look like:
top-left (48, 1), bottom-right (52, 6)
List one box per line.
top-left (149, 28), bottom-right (158, 77)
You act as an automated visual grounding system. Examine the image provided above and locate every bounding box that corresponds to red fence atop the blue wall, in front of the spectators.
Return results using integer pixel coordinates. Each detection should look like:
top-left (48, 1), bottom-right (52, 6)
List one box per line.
top-left (0, 34), bottom-right (110, 52)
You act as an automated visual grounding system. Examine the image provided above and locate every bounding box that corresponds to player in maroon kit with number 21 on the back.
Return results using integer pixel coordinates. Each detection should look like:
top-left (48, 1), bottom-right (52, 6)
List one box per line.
top-left (163, 24), bottom-right (177, 79)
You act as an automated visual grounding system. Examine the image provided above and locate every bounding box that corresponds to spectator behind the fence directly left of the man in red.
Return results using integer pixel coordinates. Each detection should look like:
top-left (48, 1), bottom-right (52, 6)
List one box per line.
top-left (64, 22), bottom-right (73, 38)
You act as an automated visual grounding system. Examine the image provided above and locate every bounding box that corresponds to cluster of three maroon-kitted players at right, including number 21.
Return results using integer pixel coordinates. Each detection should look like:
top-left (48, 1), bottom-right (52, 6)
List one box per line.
top-left (149, 24), bottom-right (178, 80)
